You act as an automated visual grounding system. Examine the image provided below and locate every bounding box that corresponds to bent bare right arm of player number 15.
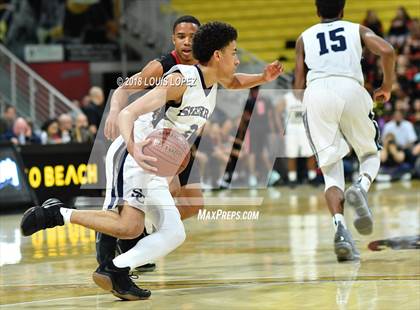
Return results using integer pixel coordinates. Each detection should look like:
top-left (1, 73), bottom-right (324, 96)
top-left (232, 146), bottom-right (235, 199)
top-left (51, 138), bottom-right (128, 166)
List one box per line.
top-left (360, 25), bottom-right (395, 101)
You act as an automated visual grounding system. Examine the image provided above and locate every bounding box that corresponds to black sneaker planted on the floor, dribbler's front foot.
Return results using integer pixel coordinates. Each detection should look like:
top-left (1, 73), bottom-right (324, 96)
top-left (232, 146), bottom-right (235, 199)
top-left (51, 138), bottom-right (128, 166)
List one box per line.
top-left (92, 261), bottom-right (152, 300)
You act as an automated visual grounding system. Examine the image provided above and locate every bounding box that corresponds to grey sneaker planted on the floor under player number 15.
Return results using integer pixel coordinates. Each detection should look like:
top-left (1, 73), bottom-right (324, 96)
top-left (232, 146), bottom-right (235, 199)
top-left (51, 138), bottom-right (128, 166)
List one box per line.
top-left (334, 223), bottom-right (360, 262)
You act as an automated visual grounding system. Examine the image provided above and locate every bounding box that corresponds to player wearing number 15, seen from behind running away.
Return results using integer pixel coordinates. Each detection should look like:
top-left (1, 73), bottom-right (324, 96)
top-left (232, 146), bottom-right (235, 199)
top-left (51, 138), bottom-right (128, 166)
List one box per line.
top-left (295, 0), bottom-right (395, 261)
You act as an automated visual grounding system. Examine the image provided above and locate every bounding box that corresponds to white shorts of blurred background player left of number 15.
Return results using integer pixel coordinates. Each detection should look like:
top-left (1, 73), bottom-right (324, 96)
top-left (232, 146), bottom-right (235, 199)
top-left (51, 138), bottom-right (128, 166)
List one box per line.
top-left (285, 123), bottom-right (314, 158)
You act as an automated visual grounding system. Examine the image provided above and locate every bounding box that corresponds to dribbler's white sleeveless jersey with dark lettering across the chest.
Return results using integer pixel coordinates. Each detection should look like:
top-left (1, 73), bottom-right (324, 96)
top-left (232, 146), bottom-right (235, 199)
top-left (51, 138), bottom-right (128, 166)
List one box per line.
top-left (137, 65), bottom-right (217, 139)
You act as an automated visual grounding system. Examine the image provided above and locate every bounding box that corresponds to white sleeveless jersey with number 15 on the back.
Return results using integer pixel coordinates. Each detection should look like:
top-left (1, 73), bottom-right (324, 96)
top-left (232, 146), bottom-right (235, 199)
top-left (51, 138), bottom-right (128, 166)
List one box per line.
top-left (302, 20), bottom-right (364, 85)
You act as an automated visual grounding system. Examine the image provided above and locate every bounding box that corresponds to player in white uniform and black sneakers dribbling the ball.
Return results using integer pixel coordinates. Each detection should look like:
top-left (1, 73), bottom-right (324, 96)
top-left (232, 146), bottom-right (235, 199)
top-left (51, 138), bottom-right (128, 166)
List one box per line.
top-left (21, 22), bottom-right (283, 300)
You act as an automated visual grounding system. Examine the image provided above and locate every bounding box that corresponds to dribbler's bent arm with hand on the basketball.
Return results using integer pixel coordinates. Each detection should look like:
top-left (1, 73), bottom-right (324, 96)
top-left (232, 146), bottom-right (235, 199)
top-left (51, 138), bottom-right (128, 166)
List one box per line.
top-left (118, 73), bottom-right (187, 173)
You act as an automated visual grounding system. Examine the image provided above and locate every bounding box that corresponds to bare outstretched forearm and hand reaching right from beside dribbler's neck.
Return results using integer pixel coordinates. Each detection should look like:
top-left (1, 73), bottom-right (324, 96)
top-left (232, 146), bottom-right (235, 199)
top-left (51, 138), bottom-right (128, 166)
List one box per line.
top-left (222, 60), bottom-right (284, 89)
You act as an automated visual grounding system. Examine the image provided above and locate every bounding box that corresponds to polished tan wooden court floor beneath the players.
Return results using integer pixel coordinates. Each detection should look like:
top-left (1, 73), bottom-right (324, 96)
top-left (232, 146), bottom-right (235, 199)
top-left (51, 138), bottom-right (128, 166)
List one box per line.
top-left (0, 182), bottom-right (420, 310)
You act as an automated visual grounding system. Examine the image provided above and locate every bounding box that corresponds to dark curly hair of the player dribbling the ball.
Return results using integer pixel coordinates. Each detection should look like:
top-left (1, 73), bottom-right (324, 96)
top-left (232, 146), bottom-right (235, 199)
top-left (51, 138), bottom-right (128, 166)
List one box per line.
top-left (193, 22), bottom-right (238, 63)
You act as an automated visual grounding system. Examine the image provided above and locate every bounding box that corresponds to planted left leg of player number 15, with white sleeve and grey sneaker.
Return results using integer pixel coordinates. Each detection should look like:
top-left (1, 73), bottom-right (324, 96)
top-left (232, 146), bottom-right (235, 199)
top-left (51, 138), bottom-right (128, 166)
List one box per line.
top-left (321, 160), bottom-right (360, 261)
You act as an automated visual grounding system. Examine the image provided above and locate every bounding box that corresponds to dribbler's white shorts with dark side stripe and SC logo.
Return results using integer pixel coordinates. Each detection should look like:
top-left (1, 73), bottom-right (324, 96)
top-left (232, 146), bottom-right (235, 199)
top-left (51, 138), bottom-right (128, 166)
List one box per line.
top-left (103, 136), bottom-right (177, 214)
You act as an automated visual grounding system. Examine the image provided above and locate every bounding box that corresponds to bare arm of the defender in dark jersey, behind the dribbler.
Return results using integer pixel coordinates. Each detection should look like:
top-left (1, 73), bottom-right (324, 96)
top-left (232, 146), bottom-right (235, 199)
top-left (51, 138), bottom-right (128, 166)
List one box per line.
top-left (104, 60), bottom-right (163, 140)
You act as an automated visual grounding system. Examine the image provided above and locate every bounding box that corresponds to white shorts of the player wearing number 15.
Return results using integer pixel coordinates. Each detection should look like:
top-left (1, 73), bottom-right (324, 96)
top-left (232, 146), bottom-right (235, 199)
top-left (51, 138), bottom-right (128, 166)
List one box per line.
top-left (303, 77), bottom-right (380, 167)
